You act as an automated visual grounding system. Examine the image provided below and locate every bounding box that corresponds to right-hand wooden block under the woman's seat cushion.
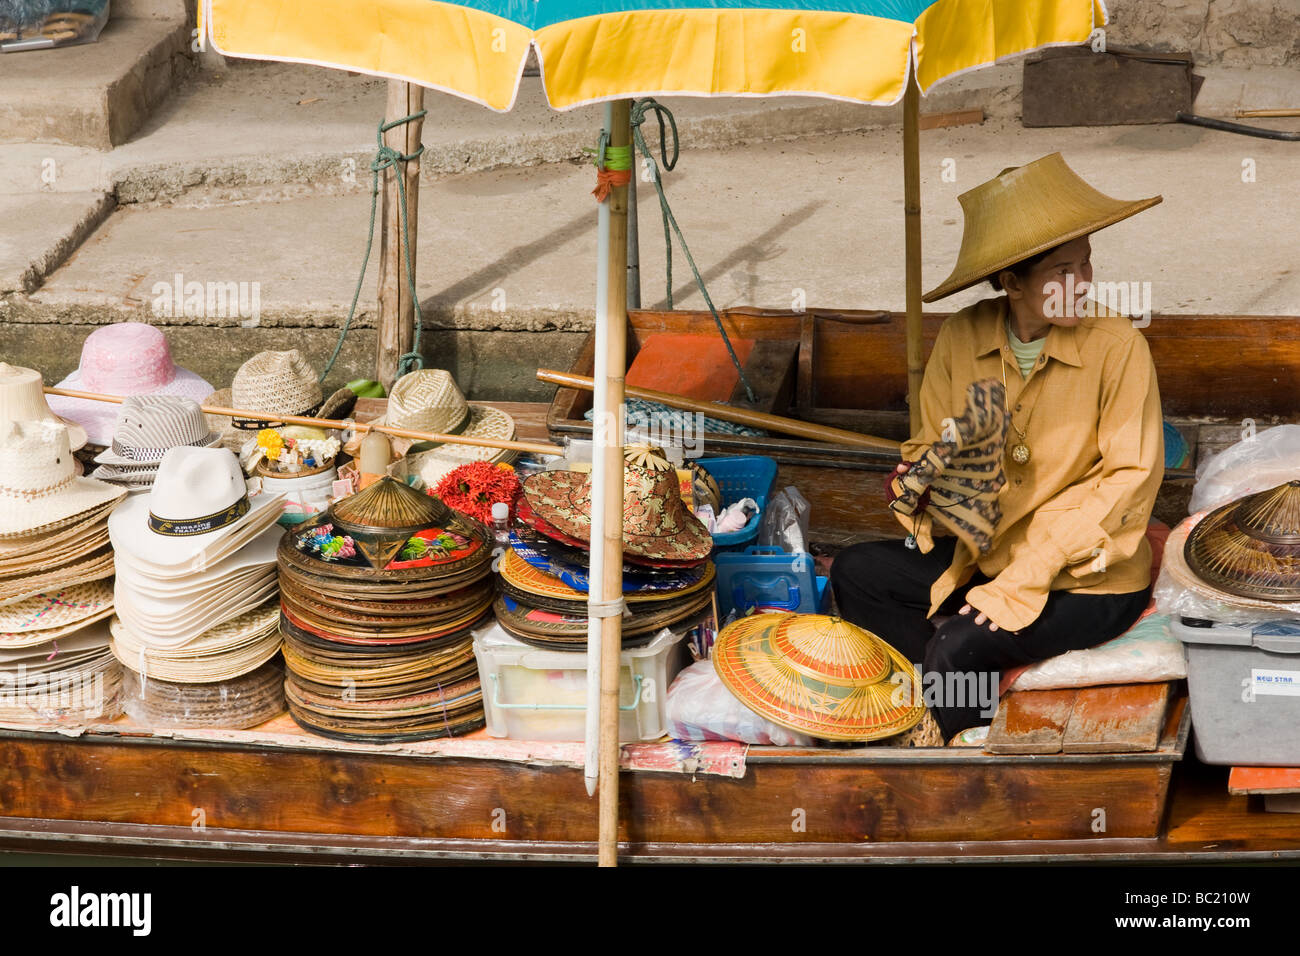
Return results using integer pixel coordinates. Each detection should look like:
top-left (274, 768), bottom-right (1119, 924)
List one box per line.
top-left (1061, 682), bottom-right (1169, 753)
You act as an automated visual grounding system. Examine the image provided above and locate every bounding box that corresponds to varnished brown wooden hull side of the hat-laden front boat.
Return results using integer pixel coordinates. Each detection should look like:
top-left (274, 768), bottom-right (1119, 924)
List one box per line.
top-left (0, 701), bottom-right (1188, 861)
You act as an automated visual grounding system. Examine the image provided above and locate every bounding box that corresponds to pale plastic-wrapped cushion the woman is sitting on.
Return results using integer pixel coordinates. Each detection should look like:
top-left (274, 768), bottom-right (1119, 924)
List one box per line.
top-left (1010, 614), bottom-right (1187, 691)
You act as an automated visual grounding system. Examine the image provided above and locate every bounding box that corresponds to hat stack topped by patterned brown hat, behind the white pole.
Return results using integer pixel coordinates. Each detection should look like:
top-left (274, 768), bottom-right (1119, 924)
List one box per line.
top-left (495, 446), bottom-right (715, 650)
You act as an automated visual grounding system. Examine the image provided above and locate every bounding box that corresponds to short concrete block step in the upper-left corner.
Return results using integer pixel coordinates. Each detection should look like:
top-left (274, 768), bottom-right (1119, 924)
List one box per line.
top-left (0, 16), bottom-right (190, 150)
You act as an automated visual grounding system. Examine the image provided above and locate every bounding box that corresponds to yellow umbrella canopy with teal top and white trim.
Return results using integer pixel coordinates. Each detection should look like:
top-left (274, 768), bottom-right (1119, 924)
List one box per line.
top-left (200, 0), bottom-right (1105, 111)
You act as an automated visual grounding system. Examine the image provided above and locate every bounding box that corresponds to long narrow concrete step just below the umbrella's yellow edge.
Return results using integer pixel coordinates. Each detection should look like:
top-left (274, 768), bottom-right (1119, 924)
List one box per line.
top-left (108, 59), bottom-right (1019, 204)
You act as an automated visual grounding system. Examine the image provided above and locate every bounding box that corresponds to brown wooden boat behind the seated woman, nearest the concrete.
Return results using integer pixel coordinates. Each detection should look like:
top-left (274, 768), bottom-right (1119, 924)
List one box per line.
top-left (547, 310), bottom-right (1300, 544)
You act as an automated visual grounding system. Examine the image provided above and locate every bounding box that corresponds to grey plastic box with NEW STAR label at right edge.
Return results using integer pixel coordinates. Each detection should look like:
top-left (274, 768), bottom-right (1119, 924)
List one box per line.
top-left (1170, 617), bottom-right (1300, 767)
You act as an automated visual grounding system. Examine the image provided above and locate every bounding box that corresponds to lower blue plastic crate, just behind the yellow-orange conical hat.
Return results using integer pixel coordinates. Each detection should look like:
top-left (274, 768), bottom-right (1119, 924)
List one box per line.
top-left (714, 546), bottom-right (827, 618)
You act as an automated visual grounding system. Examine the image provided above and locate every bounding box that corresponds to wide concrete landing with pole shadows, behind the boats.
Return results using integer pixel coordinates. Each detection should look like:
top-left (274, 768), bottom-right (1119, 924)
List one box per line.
top-left (0, 122), bottom-right (1300, 401)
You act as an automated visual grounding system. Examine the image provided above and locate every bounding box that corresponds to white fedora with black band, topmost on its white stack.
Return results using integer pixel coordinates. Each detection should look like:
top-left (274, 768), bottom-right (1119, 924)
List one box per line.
top-left (108, 446), bottom-right (282, 567)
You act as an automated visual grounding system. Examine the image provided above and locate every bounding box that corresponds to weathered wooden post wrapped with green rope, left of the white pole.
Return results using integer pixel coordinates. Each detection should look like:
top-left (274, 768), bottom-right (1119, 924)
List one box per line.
top-left (374, 79), bottom-right (424, 390)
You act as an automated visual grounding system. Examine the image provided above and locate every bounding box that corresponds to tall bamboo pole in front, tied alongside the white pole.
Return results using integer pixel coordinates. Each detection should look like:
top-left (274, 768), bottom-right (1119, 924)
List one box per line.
top-left (593, 100), bottom-right (632, 866)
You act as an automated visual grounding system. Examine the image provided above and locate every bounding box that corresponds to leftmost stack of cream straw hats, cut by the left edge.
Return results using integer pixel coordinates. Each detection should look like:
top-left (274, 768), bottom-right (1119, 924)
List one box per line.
top-left (0, 411), bottom-right (126, 726)
